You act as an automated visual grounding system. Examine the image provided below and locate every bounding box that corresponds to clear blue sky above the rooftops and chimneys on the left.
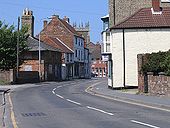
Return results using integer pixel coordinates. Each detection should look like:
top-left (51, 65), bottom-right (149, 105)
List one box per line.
top-left (0, 0), bottom-right (108, 43)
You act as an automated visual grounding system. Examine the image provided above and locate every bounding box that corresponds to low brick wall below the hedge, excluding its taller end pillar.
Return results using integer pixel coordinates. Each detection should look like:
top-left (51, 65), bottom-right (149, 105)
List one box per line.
top-left (148, 74), bottom-right (170, 96)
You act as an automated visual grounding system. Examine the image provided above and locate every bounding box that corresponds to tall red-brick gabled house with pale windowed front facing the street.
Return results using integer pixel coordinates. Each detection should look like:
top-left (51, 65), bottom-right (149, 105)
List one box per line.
top-left (40, 15), bottom-right (90, 78)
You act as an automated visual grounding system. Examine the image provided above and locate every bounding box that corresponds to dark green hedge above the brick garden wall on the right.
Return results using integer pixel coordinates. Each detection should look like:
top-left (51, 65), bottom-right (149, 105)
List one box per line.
top-left (142, 51), bottom-right (170, 75)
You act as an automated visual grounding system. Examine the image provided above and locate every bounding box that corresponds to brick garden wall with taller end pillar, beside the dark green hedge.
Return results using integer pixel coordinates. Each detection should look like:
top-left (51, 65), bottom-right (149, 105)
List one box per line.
top-left (137, 54), bottom-right (170, 96)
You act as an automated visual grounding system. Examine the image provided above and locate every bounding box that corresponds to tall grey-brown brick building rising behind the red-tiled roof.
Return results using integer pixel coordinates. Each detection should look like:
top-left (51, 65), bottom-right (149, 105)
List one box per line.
top-left (109, 0), bottom-right (170, 27)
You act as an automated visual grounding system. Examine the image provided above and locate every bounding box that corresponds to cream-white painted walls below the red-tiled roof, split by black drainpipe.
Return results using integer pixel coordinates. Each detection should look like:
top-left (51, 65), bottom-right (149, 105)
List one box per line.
top-left (112, 29), bottom-right (170, 87)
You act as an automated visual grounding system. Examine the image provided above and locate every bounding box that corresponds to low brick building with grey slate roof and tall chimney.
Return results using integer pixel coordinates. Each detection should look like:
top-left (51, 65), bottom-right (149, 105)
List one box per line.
top-left (19, 9), bottom-right (62, 82)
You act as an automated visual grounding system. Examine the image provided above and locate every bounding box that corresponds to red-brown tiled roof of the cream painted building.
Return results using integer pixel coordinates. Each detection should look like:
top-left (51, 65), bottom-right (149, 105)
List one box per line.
top-left (111, 7), bottom-right (170, 29)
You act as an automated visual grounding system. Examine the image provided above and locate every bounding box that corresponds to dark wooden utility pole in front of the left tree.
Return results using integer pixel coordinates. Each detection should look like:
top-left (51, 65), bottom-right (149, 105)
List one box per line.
top-left (17, 17), bottom-right (20, 79)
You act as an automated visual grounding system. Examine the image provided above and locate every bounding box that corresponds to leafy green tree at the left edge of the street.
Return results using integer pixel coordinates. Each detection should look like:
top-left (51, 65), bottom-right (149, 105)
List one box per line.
top-left (0, 21), bottom-right (28, 70)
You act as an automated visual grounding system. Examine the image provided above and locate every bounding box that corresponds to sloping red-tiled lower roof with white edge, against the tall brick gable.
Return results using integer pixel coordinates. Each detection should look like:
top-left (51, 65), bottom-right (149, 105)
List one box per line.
top-left (42, 36), bottom-right (74, 53)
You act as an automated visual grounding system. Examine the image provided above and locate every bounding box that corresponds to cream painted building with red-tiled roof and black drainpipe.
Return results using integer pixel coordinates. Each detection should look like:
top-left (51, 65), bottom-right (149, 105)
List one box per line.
top-left (108, 0), bottom-right (170, 88)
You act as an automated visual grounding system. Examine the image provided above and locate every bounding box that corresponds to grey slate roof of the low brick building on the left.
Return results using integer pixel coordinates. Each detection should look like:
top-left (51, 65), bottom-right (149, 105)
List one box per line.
top-left (27, 36), bottom-right (61, 52)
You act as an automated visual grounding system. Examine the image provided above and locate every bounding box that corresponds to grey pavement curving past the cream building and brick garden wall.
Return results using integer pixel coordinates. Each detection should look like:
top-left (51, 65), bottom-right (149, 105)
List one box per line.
top-left (88, 83), bottom-right (170, 112)
